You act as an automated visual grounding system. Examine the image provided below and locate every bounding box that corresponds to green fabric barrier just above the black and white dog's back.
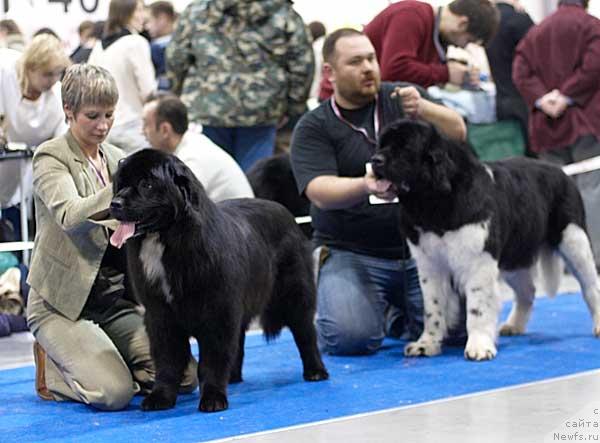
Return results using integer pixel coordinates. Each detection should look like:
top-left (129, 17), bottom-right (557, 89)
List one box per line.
top-left (467, 120), bottom-right (525, 161)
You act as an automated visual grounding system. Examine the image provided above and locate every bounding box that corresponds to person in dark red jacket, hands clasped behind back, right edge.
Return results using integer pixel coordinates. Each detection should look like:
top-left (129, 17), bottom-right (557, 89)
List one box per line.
top-left (512, 0), bottom-right (600, 263)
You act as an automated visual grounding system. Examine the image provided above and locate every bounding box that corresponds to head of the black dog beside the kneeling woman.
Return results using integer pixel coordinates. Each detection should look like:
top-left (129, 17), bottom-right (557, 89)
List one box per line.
top-left (110, 149), bottom-right (207, 241)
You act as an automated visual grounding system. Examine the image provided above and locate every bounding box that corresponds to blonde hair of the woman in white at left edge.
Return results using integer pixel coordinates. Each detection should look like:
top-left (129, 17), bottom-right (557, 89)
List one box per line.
top-left (17, 34), bottom-right (71, 94)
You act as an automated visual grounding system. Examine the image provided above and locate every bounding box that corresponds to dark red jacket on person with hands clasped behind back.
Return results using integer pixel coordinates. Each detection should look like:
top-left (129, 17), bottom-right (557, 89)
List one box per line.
top-left (513, 5), bottom-right (600, 152)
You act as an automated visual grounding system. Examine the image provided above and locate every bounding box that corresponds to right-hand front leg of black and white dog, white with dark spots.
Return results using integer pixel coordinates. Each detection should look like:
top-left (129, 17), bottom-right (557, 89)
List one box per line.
top-left (464, 253), bottom-right (500, 360)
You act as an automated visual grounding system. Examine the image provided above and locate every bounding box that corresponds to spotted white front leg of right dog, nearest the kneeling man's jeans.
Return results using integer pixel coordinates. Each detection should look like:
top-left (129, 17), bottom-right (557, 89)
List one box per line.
top-left (404, 249), bottom-right (451, 357)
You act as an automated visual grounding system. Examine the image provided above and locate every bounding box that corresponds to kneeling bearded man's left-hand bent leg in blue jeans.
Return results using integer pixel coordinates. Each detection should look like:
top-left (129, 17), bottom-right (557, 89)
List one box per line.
top-left (317, 248), bottom-right (393, 355)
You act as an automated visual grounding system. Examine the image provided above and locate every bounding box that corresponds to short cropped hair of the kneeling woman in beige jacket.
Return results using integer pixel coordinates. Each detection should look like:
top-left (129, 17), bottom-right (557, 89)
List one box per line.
top-left (61, 63), bottom-right (119, 115)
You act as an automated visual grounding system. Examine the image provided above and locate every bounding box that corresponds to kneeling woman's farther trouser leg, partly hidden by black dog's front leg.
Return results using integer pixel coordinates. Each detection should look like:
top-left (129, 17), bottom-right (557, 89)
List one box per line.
top-left (102, 309), bottom-right (198, 394)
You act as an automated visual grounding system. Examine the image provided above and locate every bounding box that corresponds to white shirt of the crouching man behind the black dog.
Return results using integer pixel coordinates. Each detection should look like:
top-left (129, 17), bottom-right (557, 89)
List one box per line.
top-left (174, 128), bottom-right (254, 201)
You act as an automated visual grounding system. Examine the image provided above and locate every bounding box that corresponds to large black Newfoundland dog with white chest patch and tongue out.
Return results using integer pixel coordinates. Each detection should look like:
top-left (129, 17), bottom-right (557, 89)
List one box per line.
top-left (110, 149), bottom-right (328, 412)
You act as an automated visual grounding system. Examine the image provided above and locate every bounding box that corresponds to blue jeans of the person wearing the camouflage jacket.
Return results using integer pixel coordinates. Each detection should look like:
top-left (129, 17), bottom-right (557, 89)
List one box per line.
top-left (202, 125), bottom-right (276, 172)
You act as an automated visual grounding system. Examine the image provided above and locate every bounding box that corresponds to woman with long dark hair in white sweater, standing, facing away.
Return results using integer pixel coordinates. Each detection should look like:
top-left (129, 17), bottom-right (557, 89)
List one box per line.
top-left (88, 0), bottom-right (156, 153)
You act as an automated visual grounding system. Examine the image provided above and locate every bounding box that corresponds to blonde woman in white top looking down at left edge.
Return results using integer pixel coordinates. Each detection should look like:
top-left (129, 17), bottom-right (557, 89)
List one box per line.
top-left (0, 34), bottom-right (71, 207)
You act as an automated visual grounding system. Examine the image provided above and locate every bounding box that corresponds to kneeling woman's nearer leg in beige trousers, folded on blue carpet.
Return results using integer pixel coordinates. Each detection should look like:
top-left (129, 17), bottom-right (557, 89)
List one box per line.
top-left (27, 289), bottom-right (136, 410)
